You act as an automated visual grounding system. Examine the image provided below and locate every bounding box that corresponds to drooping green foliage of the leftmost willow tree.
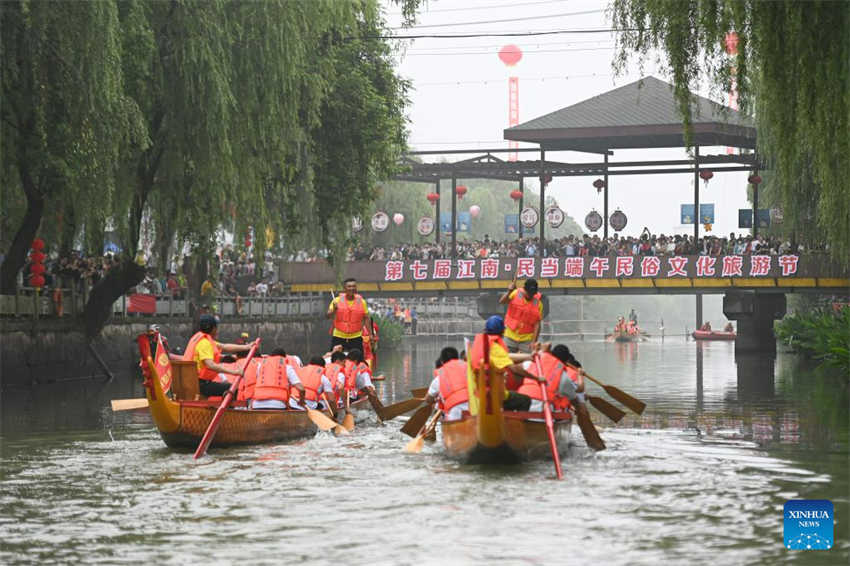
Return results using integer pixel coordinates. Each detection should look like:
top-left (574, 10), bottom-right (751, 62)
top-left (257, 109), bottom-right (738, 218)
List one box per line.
top-left (0, 2), bottom-right (144, 293)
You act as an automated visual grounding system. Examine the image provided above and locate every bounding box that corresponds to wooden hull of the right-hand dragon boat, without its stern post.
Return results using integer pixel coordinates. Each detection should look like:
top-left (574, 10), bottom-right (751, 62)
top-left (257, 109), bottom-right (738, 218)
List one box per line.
top-left (442, 412), bottom-right (572, 464)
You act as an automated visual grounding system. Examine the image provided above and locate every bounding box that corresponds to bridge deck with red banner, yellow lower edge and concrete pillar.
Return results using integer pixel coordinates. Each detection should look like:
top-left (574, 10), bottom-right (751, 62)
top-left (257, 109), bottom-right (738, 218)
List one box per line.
top-left (278, 254), bottom-right (850, 350)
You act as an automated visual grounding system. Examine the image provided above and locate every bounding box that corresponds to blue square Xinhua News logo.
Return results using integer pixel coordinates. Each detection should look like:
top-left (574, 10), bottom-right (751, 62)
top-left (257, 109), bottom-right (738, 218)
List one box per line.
top-left (784, 499), bottom-right (834, 550)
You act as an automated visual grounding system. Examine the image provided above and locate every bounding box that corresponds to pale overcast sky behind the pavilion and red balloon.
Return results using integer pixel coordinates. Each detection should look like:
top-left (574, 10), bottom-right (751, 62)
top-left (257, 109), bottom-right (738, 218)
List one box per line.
top-left (386, 0), bottom-right (750, 239)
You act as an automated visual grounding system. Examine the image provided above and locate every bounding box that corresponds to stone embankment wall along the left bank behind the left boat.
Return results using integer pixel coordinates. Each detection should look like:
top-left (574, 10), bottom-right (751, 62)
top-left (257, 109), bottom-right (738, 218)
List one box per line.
top-left (0, 317), bottom-right (330, 389)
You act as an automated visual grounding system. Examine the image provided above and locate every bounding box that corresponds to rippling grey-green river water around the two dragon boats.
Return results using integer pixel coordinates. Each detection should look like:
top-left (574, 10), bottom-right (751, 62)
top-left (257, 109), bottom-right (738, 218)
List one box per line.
top-left (0, 338), bottom-right (850, 565)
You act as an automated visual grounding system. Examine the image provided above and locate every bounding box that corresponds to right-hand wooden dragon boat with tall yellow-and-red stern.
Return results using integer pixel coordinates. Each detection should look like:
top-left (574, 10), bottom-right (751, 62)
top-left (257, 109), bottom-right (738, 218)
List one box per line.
top-left (441, 362), bottom-right (572, 464)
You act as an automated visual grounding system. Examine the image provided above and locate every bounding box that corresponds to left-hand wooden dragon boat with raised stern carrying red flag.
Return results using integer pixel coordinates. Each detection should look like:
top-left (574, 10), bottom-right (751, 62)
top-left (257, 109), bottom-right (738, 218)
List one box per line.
top-left (137, 334), bottom-right (369, 450)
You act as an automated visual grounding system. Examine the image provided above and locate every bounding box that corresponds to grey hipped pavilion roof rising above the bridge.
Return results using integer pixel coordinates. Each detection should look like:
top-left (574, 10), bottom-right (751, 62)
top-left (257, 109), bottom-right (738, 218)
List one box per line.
top-left (504, 77), bottom-right (756, 153)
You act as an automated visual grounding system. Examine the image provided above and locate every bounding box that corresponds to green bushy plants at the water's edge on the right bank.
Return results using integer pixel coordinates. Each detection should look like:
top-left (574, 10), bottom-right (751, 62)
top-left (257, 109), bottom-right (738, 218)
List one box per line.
top-left (776, 306), bottom-right (850, 375)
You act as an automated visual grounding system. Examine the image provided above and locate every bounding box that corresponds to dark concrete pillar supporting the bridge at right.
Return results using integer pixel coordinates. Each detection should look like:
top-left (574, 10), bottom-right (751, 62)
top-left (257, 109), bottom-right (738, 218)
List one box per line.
top-left (723, 291), bottom-right (786, 353)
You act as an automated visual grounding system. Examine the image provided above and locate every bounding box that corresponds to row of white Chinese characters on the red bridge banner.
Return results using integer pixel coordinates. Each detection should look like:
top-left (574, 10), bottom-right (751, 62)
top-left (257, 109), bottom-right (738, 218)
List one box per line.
top-left (383, 255), bottom-right (800, 281)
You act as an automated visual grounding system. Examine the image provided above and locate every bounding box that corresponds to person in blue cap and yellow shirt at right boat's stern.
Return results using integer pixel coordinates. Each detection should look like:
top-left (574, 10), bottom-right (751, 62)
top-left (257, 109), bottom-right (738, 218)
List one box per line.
top-left (467, 315), bottom-right (543, 411)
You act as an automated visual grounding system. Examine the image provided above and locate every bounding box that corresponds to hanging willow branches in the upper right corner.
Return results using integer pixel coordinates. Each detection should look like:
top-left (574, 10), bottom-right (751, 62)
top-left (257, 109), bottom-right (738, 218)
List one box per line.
top-left (612, 0), bottom-right (850, 262)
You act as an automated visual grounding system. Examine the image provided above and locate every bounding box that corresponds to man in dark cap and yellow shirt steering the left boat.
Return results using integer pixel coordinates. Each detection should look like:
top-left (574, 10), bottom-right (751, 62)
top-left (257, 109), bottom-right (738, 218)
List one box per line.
top-left (183, 314), bottom-right (251, 397)
